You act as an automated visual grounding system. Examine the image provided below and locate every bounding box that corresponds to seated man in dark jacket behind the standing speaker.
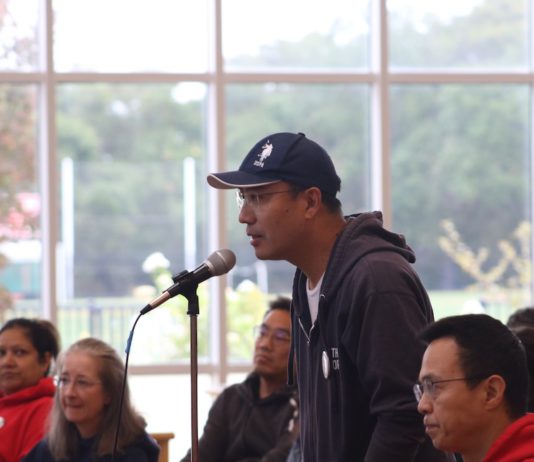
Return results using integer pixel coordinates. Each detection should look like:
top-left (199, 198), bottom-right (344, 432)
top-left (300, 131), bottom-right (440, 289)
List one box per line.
top-left (182, 297), bottom-right (297, 462)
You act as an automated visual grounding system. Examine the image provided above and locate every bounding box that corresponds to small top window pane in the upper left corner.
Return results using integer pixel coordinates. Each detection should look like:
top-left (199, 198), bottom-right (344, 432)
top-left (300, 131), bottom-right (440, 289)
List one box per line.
top-left (0, 0), bottom-right (39, 71)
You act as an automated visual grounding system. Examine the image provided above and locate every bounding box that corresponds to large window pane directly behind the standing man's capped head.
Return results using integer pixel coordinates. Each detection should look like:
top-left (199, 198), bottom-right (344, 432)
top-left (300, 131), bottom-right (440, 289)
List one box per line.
top-left (226, 84), bottom-right (370, 359)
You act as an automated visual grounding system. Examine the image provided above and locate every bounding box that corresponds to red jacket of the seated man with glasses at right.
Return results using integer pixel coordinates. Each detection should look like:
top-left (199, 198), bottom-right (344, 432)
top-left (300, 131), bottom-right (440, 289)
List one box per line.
top-left (482, 414), bottom-right (534, 462)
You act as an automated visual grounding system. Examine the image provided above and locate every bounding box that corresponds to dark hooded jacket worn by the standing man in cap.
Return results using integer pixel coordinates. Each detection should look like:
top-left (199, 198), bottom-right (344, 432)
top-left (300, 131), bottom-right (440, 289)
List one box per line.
top-left (290, 212), bottom-right (452, 462)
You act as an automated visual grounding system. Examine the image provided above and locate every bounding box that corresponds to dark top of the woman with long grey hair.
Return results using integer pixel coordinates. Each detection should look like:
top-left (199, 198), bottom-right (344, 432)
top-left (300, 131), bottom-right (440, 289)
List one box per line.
top-left (22, 432), bottom-right (159, 462)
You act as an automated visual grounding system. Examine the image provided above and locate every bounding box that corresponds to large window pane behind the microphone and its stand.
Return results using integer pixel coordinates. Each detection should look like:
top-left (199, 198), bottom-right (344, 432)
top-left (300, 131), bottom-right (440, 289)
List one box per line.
top-left (57, 83), bottom-right (208, 363)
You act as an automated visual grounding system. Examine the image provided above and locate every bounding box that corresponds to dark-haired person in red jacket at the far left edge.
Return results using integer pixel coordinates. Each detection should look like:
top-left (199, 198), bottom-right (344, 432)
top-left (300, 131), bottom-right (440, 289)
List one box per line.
top-left (0, 318), bottom-right (60, 462)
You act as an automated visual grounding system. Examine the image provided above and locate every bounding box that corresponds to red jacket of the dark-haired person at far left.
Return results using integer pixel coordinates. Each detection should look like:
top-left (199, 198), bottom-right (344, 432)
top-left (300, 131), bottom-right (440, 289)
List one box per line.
top-left (0, 377), bottom-right (55, 462)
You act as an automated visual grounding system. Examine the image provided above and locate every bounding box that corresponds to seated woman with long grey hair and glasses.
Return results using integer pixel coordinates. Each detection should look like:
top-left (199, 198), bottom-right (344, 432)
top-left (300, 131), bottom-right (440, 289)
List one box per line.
top-left (23, 338), bottom-right (159, 462)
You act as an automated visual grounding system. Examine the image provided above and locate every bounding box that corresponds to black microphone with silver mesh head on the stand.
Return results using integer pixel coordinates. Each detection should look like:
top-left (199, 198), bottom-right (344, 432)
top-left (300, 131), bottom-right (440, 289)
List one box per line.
top-left (141, 249), bottom-right (235, 315)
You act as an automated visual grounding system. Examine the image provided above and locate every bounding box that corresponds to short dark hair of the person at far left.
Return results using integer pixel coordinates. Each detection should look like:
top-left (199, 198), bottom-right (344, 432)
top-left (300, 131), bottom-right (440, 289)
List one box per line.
top-left (0, 318), bottom-right (61, 374)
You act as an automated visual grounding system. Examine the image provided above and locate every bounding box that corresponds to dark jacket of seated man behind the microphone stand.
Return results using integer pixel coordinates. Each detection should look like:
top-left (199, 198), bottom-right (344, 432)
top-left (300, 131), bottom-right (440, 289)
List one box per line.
top-left (181, 373), bottom-right (297, 462)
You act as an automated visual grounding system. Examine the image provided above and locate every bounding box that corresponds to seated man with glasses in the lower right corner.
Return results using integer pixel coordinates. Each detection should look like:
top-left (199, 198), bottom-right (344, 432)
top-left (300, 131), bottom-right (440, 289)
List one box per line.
top-left (414, 314), bottom-right (534, 462)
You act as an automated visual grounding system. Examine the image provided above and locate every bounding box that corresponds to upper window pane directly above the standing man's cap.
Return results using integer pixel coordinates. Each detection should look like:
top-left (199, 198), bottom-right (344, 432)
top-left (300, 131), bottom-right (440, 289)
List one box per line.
top-left (222, 0), bottom-right (369, 70)
